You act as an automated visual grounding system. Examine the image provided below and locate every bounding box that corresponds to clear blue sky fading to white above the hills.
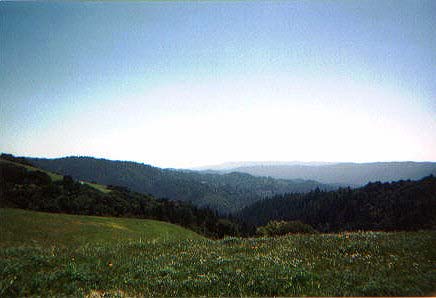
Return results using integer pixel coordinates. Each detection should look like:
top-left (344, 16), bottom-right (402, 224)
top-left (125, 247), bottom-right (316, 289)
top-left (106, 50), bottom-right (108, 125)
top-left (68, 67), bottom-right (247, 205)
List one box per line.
top-left (0, 0), bottom-right (436, 168)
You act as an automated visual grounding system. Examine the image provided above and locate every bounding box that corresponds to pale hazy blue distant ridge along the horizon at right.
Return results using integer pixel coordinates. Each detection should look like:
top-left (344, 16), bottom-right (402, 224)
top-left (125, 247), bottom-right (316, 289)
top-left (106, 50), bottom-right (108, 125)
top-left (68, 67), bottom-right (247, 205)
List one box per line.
top-left (199, 161), bottom-right (436, 186)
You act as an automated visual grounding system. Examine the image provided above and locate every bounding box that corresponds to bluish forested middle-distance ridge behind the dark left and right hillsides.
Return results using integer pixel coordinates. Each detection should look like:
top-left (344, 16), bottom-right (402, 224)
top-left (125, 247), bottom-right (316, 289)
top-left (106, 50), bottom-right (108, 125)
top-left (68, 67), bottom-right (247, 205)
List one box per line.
top-left (28, 157), bottom-right (333, 213)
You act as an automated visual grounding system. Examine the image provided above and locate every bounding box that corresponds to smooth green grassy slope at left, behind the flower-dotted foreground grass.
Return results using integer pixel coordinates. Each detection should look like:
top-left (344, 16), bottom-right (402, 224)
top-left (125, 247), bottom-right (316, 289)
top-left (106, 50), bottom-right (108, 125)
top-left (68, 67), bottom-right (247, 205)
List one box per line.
top-left (0, 209), bottom-right (202, 247)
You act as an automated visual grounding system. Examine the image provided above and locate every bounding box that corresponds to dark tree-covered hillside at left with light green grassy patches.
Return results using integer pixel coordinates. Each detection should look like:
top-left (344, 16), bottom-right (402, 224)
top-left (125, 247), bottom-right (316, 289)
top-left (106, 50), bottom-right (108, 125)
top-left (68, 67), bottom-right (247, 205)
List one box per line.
top-left (0, 155), bottom-right (250, 237)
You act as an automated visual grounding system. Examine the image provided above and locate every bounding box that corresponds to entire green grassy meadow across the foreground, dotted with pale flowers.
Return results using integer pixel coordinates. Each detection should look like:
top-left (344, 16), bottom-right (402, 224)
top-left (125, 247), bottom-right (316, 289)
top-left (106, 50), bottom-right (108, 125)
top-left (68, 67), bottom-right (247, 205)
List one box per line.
top-left (0, 209), bottom-right (436, 297)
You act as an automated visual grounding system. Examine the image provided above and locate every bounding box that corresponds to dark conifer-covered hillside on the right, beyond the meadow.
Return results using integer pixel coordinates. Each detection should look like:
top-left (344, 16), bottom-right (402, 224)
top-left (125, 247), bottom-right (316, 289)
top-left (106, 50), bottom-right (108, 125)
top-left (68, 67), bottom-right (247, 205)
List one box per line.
top-left (238, 176), bottom-right (436, 232)
